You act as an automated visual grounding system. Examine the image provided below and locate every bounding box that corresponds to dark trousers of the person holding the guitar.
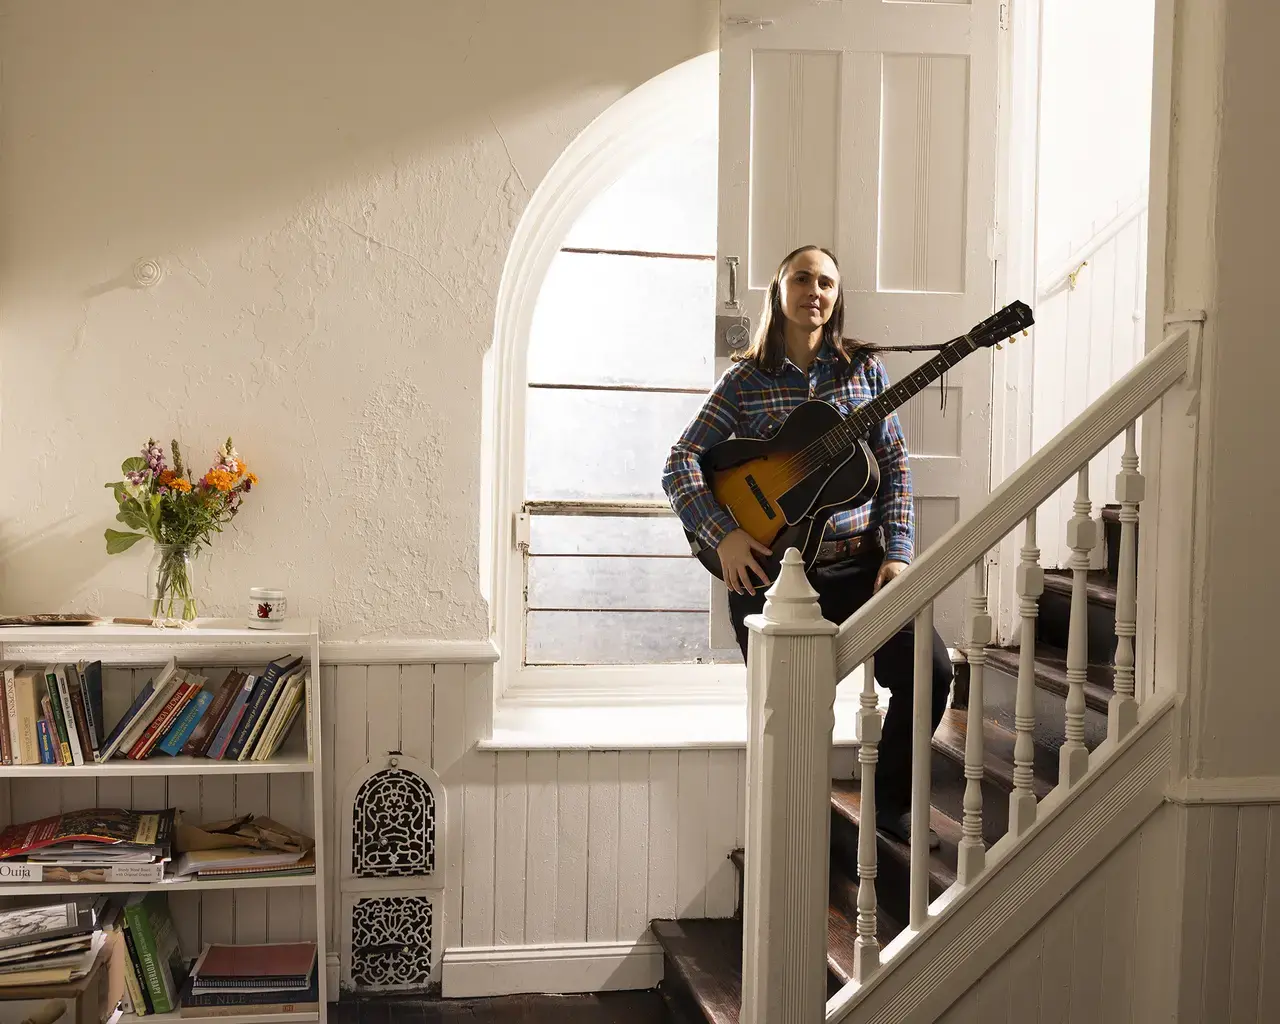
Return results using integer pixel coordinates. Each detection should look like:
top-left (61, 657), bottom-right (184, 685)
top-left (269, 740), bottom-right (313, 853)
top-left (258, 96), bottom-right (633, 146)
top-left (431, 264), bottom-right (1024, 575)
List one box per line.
top-left (728, 553), bottom-right (952, 814)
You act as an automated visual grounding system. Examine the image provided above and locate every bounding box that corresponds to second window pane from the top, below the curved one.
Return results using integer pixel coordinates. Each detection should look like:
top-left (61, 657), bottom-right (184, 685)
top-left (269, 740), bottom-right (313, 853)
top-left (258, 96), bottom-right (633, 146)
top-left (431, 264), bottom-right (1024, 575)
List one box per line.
top-left (529, 252), bottom-right (716, 388)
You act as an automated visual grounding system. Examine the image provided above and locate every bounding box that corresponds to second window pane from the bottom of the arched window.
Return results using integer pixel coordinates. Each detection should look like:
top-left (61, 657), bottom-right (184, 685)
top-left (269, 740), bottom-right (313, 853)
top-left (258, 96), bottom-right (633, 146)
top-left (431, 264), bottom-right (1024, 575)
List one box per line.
top-left (529, 554), bottom-right (712, 612)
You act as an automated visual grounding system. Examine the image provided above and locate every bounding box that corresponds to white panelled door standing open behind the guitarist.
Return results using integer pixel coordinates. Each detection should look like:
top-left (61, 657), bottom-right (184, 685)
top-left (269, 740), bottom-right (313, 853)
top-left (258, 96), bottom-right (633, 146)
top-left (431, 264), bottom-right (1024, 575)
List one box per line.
top-left (717, 0), bottom-right (1001, 644)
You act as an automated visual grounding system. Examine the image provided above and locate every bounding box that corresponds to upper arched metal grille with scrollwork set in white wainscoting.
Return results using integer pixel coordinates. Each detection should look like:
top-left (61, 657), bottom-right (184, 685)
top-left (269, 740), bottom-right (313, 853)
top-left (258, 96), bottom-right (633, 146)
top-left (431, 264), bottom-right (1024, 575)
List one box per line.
top-left (351, 768), bottom-right (435, 878)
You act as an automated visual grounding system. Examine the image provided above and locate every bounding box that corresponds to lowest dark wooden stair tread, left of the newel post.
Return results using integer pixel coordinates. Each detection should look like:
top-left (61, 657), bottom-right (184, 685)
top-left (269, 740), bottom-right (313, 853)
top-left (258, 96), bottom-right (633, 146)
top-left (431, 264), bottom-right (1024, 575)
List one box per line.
top-left (649, 918), bottom-right (742, 1024)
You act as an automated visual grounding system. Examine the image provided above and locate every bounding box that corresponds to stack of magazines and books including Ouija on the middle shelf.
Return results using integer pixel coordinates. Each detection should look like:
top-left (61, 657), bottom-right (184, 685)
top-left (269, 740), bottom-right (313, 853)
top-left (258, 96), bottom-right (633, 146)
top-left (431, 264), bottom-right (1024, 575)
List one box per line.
top-left (0, 808), bottom-right (175, 884)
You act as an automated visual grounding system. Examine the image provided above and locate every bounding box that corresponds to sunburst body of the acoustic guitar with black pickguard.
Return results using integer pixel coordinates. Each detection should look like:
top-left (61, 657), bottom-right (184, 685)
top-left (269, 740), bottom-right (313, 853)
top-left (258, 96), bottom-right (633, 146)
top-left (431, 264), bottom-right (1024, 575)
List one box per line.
top-left (686, 401), bottom-right (879, 580)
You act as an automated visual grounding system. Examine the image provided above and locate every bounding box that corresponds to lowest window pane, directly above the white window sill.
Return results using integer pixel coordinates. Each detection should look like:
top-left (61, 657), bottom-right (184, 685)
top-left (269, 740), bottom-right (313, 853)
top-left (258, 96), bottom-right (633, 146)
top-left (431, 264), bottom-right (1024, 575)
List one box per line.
top-left (525, 612), bottom-right (742, 664)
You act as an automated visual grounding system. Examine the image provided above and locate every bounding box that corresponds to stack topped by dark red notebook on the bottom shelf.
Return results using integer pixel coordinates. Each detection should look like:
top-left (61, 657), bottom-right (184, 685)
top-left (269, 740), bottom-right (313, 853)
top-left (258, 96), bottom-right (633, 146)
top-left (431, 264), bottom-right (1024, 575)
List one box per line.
top-left (180, 942), bottom-right (320, 1016)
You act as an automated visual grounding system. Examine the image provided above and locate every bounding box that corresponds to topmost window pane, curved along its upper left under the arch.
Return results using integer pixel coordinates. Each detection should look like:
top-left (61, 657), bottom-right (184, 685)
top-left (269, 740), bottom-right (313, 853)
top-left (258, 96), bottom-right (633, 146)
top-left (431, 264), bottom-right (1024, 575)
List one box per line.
top-left (564, 125), bottom-right (718, 255)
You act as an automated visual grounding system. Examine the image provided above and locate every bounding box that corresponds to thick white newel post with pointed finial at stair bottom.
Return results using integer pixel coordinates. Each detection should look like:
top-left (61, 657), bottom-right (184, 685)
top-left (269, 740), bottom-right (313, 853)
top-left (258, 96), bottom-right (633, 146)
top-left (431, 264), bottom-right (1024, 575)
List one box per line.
top-left (741, 548), bottom-right (838, 1024)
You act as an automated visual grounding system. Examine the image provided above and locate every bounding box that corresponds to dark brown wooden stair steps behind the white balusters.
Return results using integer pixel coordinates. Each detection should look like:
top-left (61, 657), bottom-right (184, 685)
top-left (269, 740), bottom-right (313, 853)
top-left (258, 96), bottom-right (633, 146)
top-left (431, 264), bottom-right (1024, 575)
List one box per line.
top-left (652, 506), bottom-right (1120, 1024)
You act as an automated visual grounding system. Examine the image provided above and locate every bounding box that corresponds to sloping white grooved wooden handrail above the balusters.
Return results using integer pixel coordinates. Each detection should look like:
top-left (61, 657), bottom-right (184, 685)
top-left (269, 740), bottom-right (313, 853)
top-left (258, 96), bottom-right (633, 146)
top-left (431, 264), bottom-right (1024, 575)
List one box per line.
top-left (836, 325), bottom-right (1190, 681)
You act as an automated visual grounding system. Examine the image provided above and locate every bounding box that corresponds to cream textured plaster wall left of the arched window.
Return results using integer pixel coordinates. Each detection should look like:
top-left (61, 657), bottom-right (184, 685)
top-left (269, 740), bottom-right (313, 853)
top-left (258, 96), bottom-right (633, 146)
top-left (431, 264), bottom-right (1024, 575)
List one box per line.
top-left (0, 0), bottom-right (716, 639)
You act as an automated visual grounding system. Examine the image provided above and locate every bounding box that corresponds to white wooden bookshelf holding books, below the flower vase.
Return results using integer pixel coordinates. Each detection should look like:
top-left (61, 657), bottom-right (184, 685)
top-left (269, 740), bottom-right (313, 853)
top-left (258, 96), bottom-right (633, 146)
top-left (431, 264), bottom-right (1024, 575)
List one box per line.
top-left (0, 618), bottom-right (337, 1024)
